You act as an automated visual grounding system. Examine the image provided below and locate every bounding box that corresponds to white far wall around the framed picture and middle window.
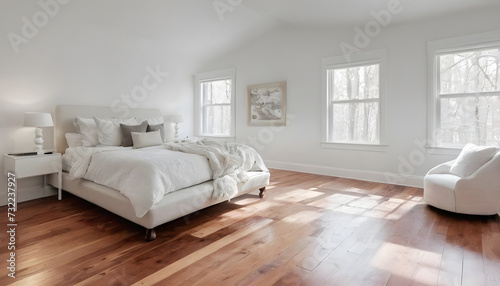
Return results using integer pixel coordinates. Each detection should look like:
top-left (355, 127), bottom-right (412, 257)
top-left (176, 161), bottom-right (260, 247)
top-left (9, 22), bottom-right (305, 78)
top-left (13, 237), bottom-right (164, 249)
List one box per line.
top-left (200, 8), bottom-right (500, 186)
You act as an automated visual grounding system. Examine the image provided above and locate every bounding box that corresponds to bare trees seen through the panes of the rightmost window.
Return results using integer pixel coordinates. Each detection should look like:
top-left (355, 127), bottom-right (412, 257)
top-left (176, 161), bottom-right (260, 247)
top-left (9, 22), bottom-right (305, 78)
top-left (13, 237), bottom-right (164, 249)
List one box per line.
top-left (437, 48), bottom-right (500, 147)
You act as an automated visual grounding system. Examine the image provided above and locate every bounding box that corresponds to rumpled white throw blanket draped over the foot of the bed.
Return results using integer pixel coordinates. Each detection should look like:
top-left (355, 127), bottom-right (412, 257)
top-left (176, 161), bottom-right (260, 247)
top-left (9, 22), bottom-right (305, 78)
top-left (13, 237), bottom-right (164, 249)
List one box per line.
top-left (167, 139), bottom-right (267, 200)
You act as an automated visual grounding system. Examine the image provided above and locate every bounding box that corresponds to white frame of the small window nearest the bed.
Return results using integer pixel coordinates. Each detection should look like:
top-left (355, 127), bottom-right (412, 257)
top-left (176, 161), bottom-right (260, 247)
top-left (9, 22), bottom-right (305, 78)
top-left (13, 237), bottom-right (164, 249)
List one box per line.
top-left (194, 68), bottom-right (236, 139)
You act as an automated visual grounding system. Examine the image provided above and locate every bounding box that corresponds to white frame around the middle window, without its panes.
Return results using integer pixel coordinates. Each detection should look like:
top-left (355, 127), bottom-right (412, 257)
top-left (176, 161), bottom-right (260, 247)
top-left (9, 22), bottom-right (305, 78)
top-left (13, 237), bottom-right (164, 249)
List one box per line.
top-left (321, 49), bottom-right (387, 152)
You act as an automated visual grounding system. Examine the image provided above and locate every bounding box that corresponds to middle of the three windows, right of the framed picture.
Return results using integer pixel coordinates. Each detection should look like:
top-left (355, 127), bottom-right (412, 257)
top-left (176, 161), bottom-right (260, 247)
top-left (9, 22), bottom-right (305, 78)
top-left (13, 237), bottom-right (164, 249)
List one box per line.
top-left (323, 51), bottom-right (385, 149)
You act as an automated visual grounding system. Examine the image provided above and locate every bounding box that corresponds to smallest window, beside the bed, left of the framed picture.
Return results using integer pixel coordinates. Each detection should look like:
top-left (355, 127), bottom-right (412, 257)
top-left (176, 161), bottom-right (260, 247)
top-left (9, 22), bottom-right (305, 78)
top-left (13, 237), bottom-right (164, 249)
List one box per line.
top-left (195, 69), bottom-right (235, 137)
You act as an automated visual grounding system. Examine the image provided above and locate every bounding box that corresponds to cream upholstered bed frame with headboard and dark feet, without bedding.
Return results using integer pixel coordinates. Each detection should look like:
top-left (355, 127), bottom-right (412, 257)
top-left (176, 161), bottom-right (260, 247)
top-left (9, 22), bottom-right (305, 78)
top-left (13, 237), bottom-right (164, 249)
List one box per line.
top-left (49, 105), bottom-right (270, 241)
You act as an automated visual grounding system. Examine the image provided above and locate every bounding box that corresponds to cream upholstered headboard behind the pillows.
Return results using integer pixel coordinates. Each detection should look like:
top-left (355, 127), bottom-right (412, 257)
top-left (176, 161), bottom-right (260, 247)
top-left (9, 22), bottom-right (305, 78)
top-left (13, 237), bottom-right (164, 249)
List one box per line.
top-left (54, 105), bottom-right (161, 153)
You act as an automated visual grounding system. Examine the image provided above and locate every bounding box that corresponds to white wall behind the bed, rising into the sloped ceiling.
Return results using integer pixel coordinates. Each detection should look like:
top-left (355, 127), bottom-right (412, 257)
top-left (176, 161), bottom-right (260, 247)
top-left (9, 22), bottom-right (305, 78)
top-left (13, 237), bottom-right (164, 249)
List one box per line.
top-left (0, 0), bottom-right (275, 205)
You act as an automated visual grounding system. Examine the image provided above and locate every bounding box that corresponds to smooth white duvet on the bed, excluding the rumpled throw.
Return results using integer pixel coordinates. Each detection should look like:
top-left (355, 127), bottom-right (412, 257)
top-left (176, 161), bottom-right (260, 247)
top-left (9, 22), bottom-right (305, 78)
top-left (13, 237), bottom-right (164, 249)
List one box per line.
top-left (66, 146), bottom-right (212, 217)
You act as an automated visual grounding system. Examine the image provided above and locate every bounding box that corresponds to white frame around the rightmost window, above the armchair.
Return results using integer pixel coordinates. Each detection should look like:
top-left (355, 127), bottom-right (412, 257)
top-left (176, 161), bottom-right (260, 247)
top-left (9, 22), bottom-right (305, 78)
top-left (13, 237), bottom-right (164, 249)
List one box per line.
top-left (427, 31), bottom-right (500, 155)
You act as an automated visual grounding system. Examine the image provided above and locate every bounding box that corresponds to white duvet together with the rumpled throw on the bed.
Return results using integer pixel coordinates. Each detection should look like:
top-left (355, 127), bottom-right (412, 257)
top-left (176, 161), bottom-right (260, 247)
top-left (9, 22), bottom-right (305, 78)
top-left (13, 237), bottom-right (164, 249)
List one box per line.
top-left (68, 140), bottom-right (267, 217)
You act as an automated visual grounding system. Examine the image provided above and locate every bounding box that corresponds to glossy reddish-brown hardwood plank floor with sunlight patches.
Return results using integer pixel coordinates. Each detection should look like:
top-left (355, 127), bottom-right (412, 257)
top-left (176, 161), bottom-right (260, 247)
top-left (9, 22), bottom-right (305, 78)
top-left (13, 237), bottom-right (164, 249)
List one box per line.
top-left (0, 170), bottom-right (500, 286)
